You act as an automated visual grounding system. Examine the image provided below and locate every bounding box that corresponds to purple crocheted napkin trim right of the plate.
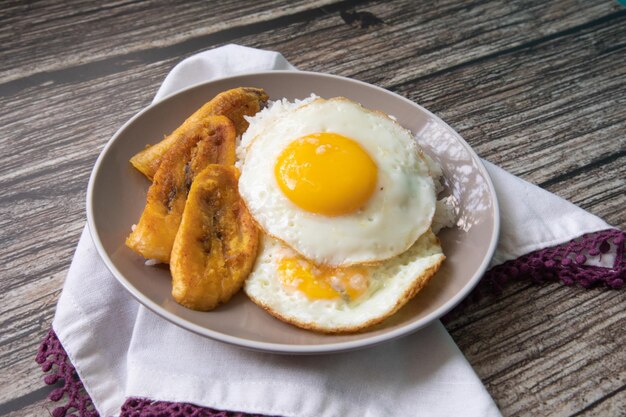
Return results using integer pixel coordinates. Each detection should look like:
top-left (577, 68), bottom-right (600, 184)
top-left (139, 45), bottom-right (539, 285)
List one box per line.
top-left (483, 229), bottom-right (626, 292)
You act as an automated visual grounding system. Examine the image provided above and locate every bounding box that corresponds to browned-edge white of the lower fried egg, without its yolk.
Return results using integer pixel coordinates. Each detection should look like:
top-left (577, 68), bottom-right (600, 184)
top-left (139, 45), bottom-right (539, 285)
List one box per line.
top-left (244, 230), bottom-right (445, 333)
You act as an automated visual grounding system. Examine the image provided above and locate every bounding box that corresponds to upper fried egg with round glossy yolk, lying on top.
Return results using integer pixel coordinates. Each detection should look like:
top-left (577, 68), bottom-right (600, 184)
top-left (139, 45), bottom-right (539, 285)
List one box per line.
top-left (239, 98), bottom-right (436, 267)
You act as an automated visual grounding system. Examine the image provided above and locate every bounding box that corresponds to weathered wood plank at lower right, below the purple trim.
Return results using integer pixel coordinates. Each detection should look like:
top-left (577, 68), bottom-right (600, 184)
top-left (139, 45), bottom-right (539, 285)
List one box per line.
top-left (446, 284), bottom-right (626, 416)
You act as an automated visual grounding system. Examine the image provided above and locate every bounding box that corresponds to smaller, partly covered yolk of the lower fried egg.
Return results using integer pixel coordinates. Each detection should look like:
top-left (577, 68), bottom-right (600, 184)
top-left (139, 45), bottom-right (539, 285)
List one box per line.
top-left (278, 257), bottom-right (369, 301)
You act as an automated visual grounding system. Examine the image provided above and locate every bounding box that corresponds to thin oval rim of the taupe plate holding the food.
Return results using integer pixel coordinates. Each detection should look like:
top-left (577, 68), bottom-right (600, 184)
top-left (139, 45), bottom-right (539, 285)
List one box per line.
top-left (86, 70), bottom-right (500, 354)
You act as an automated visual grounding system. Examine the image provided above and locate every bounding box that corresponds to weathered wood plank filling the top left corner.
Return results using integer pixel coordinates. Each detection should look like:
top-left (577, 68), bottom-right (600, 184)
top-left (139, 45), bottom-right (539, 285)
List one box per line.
top-left (0, 0), bottom-right (346, 81)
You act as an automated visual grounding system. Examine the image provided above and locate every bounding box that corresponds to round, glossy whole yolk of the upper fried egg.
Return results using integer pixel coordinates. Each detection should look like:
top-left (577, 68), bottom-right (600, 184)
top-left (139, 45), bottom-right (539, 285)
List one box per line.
top-left (274, 133), bottom-right (378, 216)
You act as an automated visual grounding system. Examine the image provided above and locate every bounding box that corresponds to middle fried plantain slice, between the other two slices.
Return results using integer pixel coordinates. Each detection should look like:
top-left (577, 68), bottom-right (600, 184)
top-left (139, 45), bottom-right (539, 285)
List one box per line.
top-left (126, 116), bottom-right (236, 263)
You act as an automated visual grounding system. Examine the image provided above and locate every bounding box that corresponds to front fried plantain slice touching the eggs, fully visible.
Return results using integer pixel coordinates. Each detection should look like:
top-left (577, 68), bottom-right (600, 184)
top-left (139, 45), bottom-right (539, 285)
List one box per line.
top-left (170, 165), bottom-right (258, 311)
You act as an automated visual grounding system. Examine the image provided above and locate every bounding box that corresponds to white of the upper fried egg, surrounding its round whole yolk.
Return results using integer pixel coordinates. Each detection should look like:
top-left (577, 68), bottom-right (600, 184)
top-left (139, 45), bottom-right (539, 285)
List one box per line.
top-left (239, 98), bottom-right (436, 266)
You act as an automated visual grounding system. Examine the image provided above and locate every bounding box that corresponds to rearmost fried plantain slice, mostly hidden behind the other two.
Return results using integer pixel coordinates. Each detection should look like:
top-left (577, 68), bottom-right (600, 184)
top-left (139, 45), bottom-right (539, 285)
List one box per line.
top-left (130, 87), bottom-right (269, 180)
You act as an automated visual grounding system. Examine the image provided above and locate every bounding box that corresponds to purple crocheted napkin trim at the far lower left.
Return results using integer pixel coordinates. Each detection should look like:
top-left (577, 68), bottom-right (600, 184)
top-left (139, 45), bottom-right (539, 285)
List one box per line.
top-left (35, 329), bottom-right (99, 417)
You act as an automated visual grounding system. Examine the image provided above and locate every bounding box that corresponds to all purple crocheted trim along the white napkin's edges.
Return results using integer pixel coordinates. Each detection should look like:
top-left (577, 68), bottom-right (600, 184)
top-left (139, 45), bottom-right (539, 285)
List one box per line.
top-left (36, 229), bottom-right (626, 417)
